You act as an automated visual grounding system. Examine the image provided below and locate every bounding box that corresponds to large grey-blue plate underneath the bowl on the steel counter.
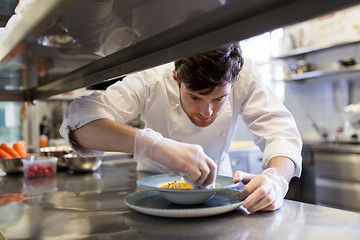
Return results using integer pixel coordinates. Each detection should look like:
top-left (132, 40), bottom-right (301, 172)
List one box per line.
top-left (125, 189), bottom-right (242, 218)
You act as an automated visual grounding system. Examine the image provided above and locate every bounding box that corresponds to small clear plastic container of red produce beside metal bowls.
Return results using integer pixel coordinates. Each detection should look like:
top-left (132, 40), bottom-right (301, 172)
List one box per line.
top-left (22, 157), bottom-right (58, 178)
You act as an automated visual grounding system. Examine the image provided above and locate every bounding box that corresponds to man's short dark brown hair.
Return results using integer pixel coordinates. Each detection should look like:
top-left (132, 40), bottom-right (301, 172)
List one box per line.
top-left (175, 43), bottom-right (244, 94)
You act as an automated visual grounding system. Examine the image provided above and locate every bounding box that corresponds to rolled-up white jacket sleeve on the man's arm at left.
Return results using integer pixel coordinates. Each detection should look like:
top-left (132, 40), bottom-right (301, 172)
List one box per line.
top-left (60, 69), bottom-right (151, 156)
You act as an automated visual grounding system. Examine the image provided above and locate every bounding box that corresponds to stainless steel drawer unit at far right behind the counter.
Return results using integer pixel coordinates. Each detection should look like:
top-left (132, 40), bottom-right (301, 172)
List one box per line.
top-left (311, 143), bottom-right (360, 212)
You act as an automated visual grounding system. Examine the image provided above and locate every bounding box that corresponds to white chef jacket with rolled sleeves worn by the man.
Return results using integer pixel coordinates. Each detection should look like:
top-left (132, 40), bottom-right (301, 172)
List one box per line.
top-left (60, 60), bottom-right (302, 177)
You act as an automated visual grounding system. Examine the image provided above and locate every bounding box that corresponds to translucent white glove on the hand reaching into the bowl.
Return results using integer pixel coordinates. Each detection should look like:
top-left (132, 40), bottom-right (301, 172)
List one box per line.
top-left (134, 128), bottom-right (217, 187)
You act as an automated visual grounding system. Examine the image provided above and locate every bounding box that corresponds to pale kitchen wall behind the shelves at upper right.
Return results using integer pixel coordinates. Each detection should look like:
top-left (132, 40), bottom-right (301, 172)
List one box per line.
top-left (235, 3), bottom-right (360, 141)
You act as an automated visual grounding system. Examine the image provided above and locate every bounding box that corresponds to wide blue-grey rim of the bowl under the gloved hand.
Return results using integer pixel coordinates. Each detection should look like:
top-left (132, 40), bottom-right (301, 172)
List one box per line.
top-left (136, 174), bottom-right (243, 193)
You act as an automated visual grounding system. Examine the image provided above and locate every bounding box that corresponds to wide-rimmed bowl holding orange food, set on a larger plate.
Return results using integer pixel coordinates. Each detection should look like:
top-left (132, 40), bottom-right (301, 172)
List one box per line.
top-left (137, 174), bottom-right (241, 205)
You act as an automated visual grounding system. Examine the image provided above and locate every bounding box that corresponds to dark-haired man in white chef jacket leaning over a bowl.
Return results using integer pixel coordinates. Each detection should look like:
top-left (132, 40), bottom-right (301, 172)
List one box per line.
top-left (60, 43), bottom-right (302, 212)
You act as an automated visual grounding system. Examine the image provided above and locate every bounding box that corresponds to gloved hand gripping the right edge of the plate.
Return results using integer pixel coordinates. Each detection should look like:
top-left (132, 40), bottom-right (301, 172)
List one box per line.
top-left (234, 168), bottom-right (289, 212)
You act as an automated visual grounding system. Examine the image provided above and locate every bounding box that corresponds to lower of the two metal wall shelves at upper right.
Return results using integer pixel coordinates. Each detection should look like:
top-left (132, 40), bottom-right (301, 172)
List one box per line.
top-left (282, 64), bottom-right (360, 82)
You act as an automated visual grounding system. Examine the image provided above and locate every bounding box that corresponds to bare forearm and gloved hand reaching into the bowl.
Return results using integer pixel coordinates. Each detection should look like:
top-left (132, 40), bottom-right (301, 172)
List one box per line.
top-left (69, 119), bottom-right (217, 187)
